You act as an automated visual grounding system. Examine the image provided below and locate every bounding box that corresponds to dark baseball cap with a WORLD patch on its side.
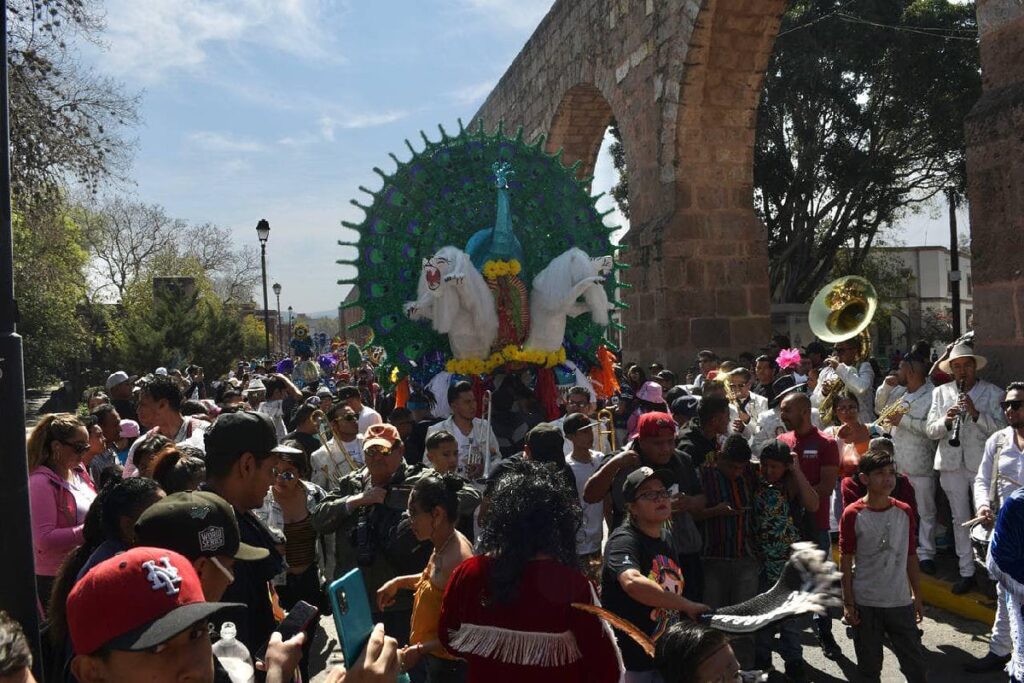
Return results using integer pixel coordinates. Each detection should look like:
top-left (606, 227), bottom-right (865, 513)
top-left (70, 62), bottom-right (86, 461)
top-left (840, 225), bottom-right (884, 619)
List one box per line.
top-left (135, 490), bottom-right (270, 560)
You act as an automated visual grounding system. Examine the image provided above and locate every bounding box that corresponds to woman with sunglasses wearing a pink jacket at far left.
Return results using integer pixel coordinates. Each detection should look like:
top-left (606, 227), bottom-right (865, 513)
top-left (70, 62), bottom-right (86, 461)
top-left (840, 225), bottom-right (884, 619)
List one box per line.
top-left (28, 413), bottom-right (96, 605)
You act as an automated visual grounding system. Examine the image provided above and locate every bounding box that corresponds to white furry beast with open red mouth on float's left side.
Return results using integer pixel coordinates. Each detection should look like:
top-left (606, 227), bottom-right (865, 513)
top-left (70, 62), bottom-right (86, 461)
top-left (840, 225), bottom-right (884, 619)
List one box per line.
top-left (406, 247), bottom-right (498, 359)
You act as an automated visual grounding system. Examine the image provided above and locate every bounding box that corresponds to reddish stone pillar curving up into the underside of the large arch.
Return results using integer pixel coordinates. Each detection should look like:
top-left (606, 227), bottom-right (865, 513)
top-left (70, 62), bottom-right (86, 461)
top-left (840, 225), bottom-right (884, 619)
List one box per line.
top-left (625, 0), bottom-right (783, 367)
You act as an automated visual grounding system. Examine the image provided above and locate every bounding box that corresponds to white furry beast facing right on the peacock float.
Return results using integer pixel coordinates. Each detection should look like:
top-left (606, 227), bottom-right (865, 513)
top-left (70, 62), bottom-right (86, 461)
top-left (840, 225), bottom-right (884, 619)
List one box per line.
top-left (523, 247), bottom-right (614, 352)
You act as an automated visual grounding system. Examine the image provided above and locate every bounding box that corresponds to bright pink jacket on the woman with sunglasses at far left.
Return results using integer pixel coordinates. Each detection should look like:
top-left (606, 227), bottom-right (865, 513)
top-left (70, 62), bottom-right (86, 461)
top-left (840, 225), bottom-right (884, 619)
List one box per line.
top-left (29, 467), bottom-right (92, 577)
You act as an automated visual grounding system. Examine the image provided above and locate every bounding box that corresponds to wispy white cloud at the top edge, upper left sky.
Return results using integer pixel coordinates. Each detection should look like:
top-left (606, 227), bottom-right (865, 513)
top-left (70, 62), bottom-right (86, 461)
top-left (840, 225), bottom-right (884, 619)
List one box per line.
top-left (102, 0), bottom-right (340, 82)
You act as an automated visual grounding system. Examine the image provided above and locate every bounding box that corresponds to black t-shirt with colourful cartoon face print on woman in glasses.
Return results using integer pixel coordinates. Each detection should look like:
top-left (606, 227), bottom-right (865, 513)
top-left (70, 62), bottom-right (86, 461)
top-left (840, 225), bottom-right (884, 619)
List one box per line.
top-left (601, 524), bottom-right (684, 671)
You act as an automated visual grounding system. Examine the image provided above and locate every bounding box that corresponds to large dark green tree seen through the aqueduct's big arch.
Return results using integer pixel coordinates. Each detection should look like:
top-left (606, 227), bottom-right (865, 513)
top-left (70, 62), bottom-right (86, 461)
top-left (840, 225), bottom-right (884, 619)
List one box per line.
top-left (754, 0), bottom-right (981, 302)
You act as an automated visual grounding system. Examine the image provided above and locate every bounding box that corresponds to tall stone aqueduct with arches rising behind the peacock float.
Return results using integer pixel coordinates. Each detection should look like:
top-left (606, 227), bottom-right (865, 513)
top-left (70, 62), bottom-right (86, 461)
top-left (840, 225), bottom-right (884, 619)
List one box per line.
top-left (475, 0), bottom-right (1024, 380)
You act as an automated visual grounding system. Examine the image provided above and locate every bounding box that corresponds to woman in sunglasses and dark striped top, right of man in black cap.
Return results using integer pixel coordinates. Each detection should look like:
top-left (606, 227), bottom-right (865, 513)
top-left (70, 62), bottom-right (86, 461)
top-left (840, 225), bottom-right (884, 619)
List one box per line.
top-left (253, 440), bottom-right (330, 681)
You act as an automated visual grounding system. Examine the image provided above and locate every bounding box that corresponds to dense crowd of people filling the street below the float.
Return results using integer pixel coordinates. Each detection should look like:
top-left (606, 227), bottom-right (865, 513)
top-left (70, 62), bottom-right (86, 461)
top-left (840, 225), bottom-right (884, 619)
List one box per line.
top-left (0, 338), bottom-right (1024, 683)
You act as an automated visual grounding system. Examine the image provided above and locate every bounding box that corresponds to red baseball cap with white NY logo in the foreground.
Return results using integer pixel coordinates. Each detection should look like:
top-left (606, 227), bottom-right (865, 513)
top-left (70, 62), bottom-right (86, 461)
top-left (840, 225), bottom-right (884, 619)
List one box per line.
top-left (68, 547), bottom-right (245, 654)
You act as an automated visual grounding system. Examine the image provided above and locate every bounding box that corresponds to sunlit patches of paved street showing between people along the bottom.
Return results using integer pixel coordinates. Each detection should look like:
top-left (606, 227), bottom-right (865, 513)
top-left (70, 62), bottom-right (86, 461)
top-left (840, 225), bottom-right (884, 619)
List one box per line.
top-left (310, 606), bottom-right (1007, 683)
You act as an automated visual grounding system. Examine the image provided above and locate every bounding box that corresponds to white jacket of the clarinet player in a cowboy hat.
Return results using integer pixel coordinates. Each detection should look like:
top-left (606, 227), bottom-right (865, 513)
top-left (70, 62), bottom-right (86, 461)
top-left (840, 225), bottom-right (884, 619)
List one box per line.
top-left (927, 380), bottom-right (1007, 477)
